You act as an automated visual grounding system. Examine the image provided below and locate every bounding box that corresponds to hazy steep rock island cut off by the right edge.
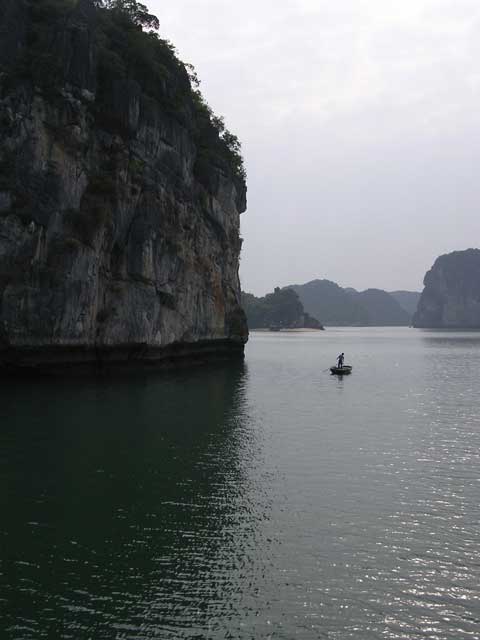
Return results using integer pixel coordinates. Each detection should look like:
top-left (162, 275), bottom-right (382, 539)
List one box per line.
top-left (413, 249), bottom-right (480, 328)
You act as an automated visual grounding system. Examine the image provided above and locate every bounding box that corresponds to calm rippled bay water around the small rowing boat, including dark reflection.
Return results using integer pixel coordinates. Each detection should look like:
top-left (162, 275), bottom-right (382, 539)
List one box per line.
top-left (0, 329), bottom-right (480, 640)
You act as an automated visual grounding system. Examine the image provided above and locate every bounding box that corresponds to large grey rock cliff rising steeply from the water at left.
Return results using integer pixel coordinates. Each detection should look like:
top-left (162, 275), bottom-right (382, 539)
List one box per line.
top-left (0, 0), bottom-right (247, 366)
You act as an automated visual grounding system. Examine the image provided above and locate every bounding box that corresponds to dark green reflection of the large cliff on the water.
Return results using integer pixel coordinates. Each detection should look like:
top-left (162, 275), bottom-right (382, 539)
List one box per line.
top-left (0, 363), bottom-right (274, 639)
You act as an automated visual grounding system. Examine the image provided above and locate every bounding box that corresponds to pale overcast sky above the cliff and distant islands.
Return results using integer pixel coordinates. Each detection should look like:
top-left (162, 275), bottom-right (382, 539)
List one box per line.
top-left (147, 0), bottom-right (480, 295)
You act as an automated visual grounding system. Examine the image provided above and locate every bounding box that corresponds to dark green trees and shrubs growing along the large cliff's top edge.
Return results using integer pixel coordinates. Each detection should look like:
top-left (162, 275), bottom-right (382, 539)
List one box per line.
top-left (13, 0), bottom-right (246, 182)
